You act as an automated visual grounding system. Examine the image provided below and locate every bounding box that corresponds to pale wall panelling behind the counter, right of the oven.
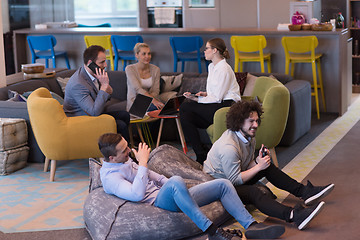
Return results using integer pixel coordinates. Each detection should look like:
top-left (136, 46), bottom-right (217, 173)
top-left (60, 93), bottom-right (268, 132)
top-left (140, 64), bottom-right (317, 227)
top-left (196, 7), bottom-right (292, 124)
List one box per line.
top-left (183, 0), bottom-right (291, 28)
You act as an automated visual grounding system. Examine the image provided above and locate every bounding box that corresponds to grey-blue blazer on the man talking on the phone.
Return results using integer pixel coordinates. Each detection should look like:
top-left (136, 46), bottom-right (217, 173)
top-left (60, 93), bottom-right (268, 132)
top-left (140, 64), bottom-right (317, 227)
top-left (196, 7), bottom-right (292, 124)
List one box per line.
top-left (63, 67), bottom-right (110, 117)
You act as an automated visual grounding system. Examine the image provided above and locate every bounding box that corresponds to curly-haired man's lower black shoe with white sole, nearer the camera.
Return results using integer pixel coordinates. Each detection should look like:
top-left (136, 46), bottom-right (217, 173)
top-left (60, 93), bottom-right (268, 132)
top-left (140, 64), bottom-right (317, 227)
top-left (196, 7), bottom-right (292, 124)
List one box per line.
top-left (292, 202), bottom-right (325, 230)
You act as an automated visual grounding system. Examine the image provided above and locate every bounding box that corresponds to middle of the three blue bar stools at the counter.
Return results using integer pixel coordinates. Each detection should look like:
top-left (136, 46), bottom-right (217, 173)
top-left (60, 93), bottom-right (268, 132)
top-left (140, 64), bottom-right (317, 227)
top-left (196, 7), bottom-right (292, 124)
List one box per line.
top-left (111, 35), bottom-right (144, 71)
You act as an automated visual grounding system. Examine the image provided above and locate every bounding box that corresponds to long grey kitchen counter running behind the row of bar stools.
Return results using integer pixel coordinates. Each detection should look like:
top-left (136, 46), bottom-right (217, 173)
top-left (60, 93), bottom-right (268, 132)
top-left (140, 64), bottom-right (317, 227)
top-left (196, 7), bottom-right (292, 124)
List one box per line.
top-left (14, 28), bottom-right (352, 115)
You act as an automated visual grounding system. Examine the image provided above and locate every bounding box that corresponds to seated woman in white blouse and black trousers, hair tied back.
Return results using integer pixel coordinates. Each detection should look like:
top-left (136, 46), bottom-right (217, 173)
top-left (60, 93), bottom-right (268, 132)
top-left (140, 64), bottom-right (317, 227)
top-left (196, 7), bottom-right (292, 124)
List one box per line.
top-left (180, 38), bottom-right (241, 164)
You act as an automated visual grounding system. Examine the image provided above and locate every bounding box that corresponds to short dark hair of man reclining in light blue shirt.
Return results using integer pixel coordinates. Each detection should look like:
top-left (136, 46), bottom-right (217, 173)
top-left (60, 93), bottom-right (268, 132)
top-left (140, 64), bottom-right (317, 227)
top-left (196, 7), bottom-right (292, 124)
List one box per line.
top-left (98, 133), bottom-right (122, 162)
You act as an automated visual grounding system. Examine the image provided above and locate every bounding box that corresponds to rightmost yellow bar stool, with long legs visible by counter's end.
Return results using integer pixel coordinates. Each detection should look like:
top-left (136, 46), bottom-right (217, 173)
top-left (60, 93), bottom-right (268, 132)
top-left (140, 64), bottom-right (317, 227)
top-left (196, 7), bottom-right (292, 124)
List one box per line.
top-left (281, 36), bottom-right (326, 119)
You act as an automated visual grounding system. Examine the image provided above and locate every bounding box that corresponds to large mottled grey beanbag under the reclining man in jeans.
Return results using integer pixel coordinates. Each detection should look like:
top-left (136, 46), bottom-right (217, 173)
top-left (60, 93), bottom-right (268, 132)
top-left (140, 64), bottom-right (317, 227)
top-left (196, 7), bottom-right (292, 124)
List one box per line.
top-left (83, 145), bottom-right (231, 240)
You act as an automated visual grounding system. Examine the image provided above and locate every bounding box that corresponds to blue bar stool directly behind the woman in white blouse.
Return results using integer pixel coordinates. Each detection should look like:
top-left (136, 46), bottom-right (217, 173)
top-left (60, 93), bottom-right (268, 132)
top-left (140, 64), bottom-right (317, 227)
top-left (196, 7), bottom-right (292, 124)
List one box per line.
top-left (169, 36), bottom-right (209, 73)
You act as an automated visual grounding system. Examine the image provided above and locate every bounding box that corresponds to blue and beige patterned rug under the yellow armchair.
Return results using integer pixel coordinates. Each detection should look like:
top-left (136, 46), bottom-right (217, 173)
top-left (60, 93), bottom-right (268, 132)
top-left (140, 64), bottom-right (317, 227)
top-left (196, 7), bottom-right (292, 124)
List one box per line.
top-left (0, 159), bottom-right (89, 233)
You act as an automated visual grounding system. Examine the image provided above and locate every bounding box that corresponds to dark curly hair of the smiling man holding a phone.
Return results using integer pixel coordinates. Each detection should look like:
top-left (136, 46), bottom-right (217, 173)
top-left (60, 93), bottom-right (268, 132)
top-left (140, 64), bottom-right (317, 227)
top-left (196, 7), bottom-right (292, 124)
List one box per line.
top-left (226, 101), bottom-right (263, 131)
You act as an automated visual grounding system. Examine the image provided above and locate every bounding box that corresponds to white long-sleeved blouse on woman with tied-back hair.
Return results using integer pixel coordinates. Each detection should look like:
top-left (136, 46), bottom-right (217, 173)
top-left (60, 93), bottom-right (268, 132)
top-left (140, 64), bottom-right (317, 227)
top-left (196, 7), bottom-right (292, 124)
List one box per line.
top-left (198, 59), bottom-right (241, 103)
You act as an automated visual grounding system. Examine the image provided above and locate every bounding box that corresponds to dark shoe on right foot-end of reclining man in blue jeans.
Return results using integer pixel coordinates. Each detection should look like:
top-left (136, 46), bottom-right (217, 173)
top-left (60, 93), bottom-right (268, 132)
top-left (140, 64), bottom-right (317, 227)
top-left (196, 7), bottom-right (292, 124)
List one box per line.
top-left (245, 223), bottom-right (285, 239)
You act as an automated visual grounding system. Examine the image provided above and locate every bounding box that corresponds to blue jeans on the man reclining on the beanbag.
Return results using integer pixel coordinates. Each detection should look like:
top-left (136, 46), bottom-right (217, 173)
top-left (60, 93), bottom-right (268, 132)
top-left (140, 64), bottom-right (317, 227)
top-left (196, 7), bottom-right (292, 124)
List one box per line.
top-left (154, 176), bottom-right (255, 232)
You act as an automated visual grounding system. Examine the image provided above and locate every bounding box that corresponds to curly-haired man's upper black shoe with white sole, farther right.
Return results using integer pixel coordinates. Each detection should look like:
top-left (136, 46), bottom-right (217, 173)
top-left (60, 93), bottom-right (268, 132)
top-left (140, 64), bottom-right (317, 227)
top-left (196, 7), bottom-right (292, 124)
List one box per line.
top-left (301, 181), bottom-right (335, 206)
